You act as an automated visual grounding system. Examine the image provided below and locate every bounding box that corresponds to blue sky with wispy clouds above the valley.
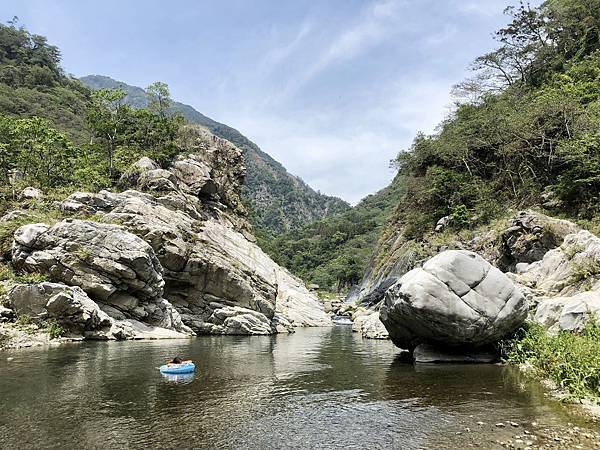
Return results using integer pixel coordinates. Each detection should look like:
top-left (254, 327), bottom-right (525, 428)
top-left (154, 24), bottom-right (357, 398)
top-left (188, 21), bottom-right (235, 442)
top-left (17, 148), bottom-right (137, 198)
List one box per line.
top-left (0, 0), bottom-right (524, 204)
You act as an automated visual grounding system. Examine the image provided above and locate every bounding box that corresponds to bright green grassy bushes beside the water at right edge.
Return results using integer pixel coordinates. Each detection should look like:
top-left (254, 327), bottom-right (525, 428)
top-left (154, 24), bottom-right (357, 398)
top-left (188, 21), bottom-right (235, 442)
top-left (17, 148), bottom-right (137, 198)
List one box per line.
top-left (507, 322), bottom-right (600, 401)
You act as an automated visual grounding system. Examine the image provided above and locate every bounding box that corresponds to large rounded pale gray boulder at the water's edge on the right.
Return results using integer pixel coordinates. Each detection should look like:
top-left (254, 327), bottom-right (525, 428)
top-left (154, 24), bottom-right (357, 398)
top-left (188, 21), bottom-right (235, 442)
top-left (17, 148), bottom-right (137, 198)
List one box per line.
top-left (380, 250), bottom-right (527, 350)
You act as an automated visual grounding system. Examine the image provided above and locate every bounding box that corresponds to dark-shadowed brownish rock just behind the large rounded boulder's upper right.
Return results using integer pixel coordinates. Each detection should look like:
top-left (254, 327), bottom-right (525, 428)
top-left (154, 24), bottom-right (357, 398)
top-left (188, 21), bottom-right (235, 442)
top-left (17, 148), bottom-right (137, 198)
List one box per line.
top-left (498, 211), bottom-right (579, 271)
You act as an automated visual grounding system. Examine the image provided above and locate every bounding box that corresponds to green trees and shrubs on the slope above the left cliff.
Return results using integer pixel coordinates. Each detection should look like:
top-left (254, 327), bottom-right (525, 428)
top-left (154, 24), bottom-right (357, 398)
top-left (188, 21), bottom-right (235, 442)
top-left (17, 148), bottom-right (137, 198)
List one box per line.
top-left (0, 22), bottom-right (182, 199)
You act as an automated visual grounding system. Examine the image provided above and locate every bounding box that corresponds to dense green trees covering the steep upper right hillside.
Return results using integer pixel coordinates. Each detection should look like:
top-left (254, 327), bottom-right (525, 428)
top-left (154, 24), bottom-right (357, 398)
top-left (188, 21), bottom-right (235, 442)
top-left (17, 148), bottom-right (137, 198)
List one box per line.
top-left (392, 0), bottom-right (600, 239)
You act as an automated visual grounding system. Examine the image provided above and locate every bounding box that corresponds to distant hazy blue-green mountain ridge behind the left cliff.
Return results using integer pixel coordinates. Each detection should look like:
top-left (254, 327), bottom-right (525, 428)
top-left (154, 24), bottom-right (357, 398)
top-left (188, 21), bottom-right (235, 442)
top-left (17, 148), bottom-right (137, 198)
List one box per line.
top-left (81, 75), bottom-right (349, 236)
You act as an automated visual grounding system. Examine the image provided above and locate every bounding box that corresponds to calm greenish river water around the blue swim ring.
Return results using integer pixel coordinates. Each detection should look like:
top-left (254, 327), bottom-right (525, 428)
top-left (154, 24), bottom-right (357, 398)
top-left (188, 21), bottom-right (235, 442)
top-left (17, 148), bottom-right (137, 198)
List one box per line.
top-left (0, 326), bottom-right (596, 449)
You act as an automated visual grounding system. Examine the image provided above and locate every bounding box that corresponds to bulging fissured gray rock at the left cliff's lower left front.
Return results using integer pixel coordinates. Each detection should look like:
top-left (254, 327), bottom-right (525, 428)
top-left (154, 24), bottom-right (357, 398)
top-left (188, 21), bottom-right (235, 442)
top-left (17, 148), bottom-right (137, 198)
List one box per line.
top-left (13, 220), bottom-right (190, 331)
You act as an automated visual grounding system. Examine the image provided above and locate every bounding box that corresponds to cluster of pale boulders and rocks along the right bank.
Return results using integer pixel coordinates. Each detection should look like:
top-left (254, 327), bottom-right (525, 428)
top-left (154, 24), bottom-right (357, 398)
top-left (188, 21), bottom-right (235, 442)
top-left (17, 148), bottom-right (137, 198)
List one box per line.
top-left (355, 211), bottom-right (600, 362)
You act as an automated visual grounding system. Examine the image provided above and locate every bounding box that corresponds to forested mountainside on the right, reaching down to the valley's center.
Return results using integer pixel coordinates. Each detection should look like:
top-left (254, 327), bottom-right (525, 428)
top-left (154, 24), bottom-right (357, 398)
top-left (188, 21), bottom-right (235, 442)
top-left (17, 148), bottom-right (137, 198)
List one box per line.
top-left (258, 0), bottom-right (600, 289)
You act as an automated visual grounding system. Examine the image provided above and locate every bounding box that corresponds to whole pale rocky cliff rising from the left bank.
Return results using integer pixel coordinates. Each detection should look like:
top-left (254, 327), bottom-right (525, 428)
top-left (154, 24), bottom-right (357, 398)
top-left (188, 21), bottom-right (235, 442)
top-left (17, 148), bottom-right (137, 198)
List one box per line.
top-left (0, 127), bottom-right (330, 338)
